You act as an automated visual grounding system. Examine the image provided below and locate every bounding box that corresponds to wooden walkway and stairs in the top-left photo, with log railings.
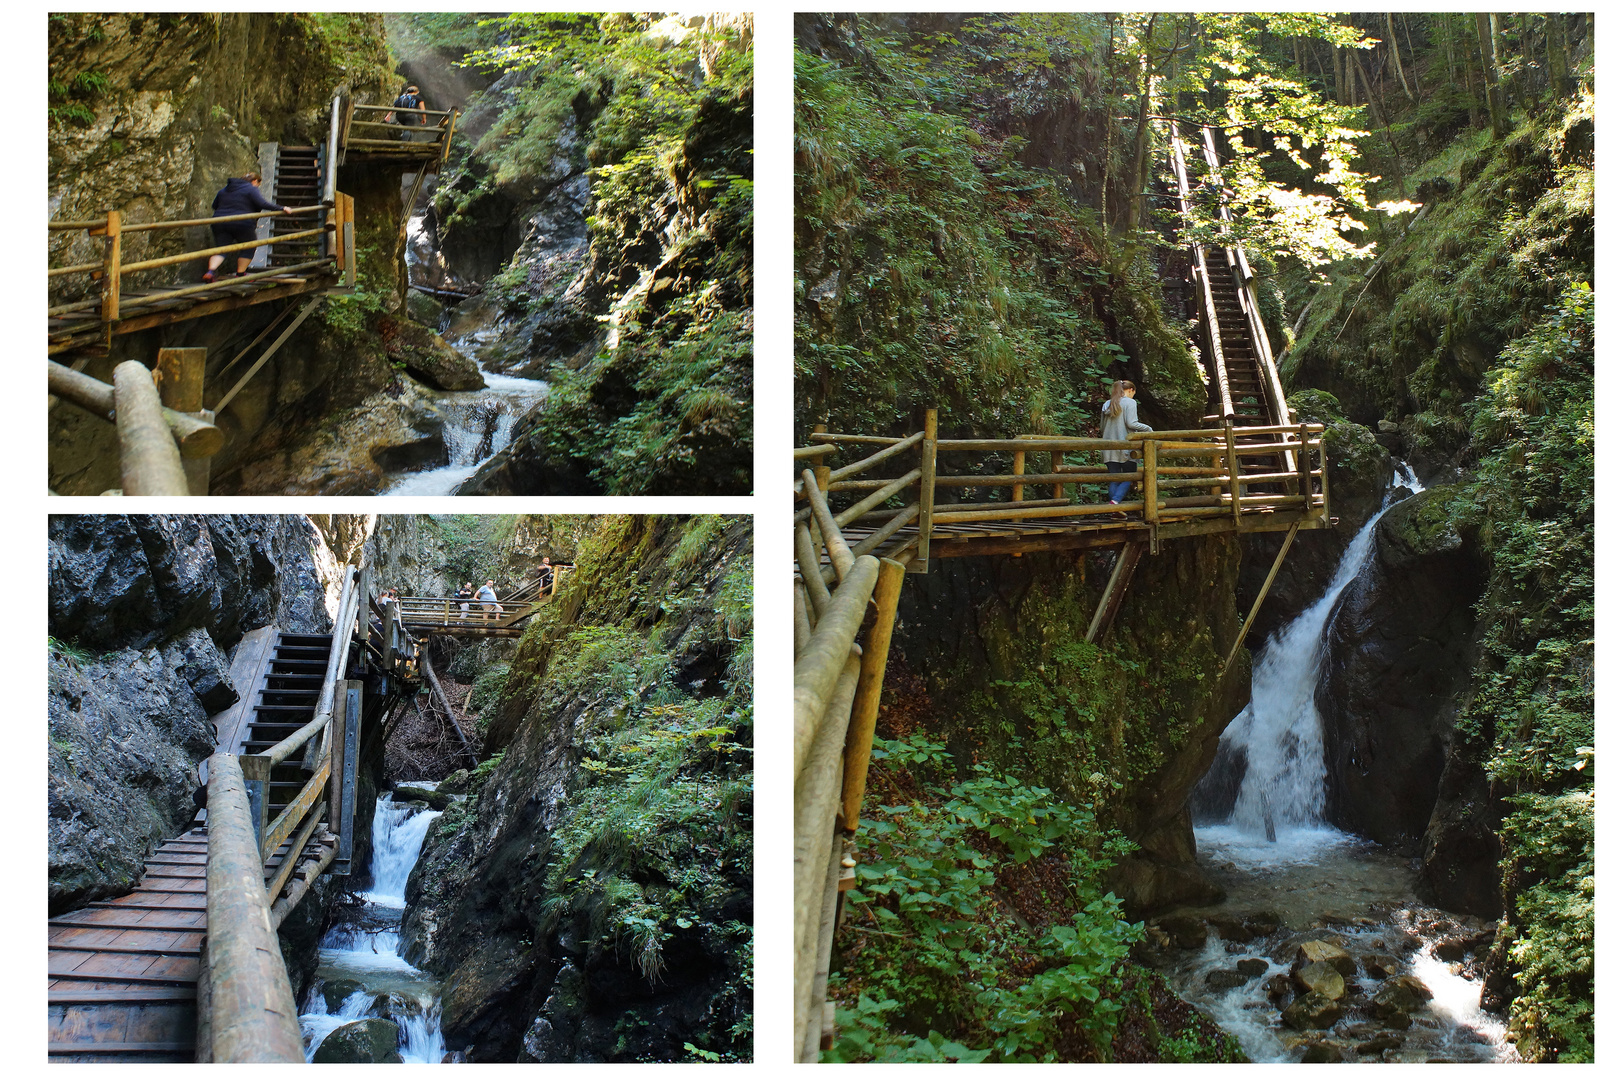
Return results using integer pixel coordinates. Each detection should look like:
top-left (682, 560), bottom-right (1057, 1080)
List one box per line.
top-left (47, 94), bottom-right (457, 495)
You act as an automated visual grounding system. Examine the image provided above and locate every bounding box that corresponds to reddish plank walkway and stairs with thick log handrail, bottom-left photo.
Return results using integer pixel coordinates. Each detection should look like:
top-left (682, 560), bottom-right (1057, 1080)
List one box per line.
top-left (47, 568), bottom-right (415, 1062)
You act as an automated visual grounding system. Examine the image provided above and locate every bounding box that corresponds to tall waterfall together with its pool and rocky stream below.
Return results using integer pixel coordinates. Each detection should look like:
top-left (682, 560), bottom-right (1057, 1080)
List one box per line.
top-left (1158, 463), bottom-right (1515, 1062)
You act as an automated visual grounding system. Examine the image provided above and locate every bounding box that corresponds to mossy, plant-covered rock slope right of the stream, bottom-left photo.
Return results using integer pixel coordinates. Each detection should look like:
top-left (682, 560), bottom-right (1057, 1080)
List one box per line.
top-left (402, 518), bottom-right (753, 1062)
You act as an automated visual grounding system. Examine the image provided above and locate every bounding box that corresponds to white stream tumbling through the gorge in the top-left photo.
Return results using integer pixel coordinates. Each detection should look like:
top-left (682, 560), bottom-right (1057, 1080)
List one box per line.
top-left (379, 204), bottom-right (549, 495)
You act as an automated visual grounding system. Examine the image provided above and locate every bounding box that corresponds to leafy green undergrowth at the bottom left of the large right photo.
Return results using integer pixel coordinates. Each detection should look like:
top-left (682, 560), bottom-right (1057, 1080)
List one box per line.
top-left (823, 735), bottom-right (1230, 1062)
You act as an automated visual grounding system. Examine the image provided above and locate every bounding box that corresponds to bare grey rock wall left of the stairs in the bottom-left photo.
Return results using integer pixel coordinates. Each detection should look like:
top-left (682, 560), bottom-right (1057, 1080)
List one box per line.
top-left (49, 515), bottom-right (332, 912)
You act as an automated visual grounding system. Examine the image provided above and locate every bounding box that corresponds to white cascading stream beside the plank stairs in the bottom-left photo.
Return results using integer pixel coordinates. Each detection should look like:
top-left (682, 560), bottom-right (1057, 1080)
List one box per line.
top-left (298, 780), bottom-right (444, 1064)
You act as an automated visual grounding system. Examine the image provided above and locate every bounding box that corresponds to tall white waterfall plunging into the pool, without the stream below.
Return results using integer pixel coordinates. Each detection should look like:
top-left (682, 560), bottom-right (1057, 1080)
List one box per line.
top-left (1199, 461), bottom-right (1422, 865)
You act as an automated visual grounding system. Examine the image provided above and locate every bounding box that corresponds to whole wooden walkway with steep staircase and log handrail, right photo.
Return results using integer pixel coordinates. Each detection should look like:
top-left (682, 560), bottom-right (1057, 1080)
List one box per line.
top-left (794, 128), bottom-right (1335, 1062)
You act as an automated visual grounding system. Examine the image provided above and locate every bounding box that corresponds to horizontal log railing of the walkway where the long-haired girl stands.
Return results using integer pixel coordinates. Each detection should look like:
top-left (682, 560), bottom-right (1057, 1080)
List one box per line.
top-left (794, 410), bottom-right (1327, 569)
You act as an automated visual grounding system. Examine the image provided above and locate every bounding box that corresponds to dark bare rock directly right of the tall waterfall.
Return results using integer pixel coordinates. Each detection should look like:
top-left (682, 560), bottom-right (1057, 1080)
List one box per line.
top-left (1317, 487), bottom-right (1484, 853)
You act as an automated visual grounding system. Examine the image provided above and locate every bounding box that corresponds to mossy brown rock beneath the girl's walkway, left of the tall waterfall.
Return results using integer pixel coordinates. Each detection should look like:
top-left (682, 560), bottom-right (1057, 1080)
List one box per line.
top-left (891, 538), bottom-right (1249, 916)
